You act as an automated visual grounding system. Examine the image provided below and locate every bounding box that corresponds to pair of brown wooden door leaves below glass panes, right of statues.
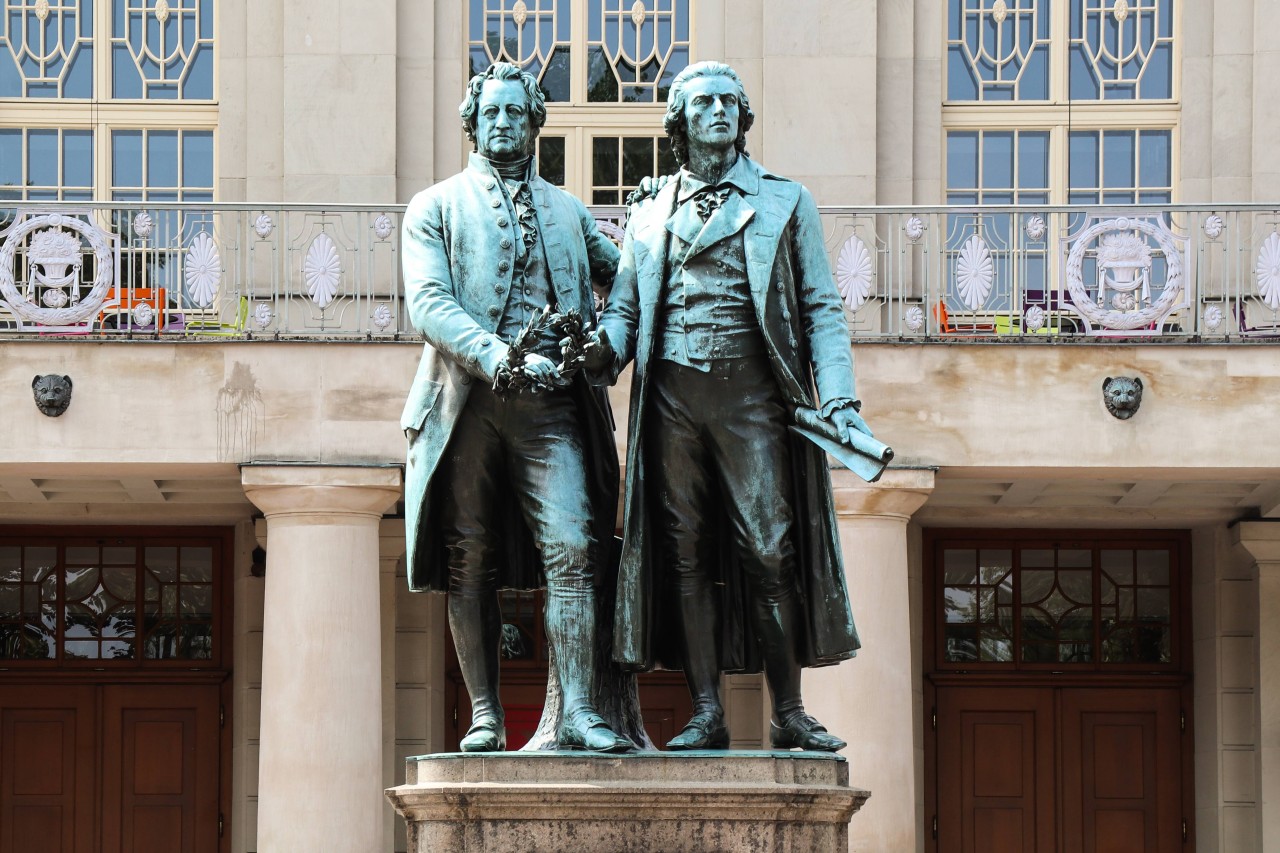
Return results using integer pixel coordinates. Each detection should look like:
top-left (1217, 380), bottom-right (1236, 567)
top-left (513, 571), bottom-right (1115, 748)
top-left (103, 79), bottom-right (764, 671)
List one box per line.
top-left (937, 686), bottom-right (1187, 853)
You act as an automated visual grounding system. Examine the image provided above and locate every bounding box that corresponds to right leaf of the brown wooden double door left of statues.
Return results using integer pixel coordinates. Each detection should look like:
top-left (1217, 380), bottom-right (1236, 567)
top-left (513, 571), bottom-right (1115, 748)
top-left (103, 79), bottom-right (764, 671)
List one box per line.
top-left (102, 685), bottom-right (219, 853)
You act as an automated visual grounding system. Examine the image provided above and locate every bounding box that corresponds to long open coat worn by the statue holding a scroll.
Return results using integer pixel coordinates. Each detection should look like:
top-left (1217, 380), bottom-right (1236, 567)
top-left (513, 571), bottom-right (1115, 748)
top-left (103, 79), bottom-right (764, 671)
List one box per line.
top-left (600, 153), bottom-right (859, 671)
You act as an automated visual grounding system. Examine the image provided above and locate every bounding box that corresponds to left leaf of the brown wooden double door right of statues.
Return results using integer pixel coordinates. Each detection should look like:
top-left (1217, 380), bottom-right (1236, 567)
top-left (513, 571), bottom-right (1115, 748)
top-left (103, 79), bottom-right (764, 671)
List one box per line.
top-left (937, 688), bottom-right (1055, 853)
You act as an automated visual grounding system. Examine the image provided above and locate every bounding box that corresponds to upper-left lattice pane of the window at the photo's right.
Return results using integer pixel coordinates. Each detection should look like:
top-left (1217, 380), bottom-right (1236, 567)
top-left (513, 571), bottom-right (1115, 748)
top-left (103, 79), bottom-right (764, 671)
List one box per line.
top-left (947, 0), bottom-right (1052, 101)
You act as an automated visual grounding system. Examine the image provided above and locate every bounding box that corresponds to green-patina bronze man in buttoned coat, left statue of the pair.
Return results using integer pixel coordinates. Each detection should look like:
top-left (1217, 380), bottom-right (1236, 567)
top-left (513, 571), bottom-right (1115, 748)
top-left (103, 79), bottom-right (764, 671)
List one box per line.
top-left (401, 63), bottom-right (649, 752)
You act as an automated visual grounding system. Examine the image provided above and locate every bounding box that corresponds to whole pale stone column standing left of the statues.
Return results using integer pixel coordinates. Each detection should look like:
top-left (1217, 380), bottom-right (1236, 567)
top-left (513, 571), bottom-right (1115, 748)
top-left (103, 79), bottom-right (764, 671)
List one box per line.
top-left (241, 465), bottom-right (401, 853)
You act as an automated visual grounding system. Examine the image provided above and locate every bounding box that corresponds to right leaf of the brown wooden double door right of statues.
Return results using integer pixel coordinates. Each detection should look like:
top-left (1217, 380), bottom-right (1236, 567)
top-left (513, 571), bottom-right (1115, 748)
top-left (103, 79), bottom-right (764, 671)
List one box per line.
top-left (1061, 688), bottom-right (1183, 853)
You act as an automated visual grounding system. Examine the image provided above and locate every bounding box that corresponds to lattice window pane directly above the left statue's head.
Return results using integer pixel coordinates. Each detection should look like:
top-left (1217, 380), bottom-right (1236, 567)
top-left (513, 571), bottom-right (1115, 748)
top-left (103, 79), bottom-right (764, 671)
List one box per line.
top-left (467, 0), bottom-right (571, 101)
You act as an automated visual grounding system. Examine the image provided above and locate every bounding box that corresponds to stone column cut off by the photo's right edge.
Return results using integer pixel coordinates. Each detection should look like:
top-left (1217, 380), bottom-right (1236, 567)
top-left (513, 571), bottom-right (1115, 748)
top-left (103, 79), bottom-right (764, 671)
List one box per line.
top-left (1231, 521), bottom-right (1280, 850)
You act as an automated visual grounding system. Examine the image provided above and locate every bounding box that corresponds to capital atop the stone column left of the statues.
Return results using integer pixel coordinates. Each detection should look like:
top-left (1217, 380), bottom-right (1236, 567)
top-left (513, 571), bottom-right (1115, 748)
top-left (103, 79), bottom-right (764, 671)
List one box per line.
top-left (241, 465), bottom-right (403, 520)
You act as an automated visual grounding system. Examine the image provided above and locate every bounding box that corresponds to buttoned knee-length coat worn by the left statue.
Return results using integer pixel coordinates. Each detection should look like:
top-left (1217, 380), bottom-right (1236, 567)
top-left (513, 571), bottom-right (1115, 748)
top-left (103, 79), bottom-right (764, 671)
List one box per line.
top-left (401, 154), bottom-right (618, 590)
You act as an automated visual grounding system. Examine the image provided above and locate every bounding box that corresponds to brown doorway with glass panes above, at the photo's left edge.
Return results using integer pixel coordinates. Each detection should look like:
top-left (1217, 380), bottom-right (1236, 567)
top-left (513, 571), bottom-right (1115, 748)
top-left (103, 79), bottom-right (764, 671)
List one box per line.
top-left (0, 529), bottom-right (230, 853)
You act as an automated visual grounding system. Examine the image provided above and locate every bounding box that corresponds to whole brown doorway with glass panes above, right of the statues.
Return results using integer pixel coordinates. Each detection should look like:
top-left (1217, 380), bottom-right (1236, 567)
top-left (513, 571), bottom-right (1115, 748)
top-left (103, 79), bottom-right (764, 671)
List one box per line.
top-left (925, 530), bottom-right (1192, 853)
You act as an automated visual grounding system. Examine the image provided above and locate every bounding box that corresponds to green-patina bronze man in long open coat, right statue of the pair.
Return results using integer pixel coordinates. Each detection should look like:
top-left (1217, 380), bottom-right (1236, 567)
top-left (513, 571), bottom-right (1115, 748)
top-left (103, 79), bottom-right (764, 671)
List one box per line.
top-left (585, 63), bottom-right (870, 751)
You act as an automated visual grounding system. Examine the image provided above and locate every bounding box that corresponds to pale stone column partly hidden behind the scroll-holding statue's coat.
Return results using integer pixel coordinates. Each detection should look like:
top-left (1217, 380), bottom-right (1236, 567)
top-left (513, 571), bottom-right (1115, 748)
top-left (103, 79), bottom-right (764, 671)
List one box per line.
top-left (804, 469), bottom-right (933, 853)
